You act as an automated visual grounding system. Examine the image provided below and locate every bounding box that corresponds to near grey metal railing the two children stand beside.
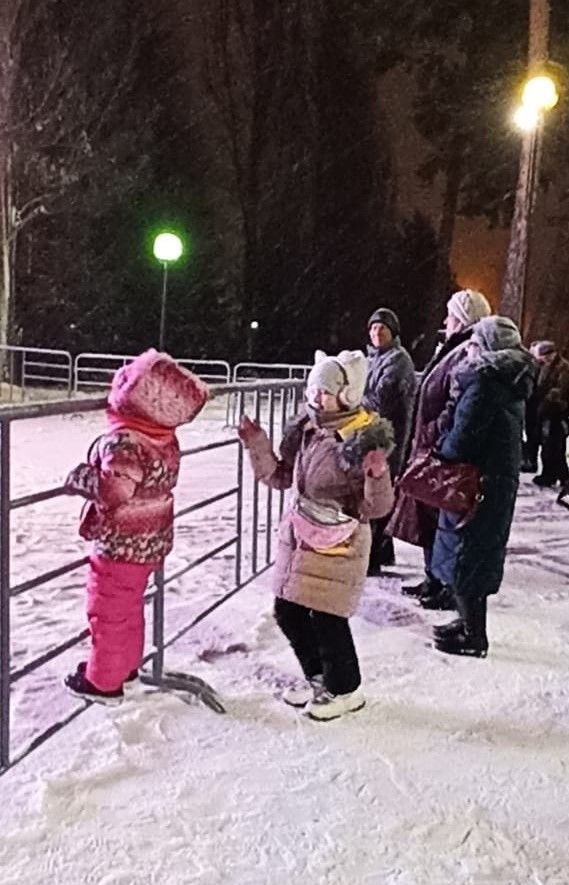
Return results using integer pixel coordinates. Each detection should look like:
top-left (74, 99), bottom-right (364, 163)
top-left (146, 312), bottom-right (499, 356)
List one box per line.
top-left (0, 381), bottom-right (303, 773)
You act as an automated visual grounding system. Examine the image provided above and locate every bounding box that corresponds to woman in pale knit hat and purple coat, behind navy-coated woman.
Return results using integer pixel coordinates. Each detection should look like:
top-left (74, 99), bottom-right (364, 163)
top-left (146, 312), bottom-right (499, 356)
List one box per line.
top-left (388, 289), bottom-right (492, 609)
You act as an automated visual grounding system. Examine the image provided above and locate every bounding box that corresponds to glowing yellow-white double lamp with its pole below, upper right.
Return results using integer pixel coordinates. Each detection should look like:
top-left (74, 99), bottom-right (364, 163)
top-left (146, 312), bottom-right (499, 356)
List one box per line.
top-left (500, 73), bottom-right (559, 333)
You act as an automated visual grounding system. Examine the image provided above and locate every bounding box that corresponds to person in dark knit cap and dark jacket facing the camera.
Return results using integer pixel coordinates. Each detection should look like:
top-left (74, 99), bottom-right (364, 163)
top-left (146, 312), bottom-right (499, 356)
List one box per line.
top-left (363, 307), bottom-right (417, 575)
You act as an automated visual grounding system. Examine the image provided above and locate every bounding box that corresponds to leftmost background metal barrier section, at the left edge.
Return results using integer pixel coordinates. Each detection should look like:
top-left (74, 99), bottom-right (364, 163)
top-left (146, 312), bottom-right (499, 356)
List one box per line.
top-left (0, 345), bottom-right (73, 402)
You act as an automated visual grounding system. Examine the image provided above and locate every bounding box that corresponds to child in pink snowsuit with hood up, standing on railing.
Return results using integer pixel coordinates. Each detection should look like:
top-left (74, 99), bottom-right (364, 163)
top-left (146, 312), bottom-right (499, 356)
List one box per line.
top-left (65, 350), bottom-right (208, 704)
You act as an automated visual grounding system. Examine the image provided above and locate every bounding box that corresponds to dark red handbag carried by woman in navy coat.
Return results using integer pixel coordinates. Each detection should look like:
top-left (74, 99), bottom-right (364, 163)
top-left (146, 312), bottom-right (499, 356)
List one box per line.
top-left (397, 454), bottom-right (484, 516)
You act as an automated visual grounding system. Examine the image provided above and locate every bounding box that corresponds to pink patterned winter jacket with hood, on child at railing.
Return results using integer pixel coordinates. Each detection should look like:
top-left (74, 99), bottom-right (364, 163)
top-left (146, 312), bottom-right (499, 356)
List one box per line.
top-left (65, 350), bottom-right (208, 565)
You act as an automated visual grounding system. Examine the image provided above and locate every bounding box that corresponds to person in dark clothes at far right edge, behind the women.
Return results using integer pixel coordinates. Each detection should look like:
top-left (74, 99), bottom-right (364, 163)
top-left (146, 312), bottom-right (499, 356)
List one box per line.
top-left (533, 341), bottom-right (569, 488)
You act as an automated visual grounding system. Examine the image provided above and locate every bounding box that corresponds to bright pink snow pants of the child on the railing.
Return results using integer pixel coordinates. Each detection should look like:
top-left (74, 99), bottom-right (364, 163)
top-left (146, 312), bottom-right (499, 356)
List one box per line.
top-left (86, 554), bottom-right (155, 691)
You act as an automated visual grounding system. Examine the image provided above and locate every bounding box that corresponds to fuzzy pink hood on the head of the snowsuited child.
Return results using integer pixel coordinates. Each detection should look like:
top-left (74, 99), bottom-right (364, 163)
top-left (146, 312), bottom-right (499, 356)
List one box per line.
top-left (109, 349), bottom-right (208, 428)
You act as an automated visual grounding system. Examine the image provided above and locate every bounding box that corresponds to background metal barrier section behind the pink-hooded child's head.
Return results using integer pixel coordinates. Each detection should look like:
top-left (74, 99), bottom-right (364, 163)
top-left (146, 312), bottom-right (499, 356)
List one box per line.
top-left (73, 353), bottom-right (231, 394)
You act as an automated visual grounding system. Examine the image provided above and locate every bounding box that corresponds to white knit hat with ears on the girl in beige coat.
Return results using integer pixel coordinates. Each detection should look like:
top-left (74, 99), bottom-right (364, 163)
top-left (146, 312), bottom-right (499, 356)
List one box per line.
top-left (306, 350), bottom-right (367, 409)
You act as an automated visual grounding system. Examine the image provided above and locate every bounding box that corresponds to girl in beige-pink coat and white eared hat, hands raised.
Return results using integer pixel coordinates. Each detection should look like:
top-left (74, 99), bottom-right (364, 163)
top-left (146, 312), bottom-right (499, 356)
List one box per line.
top-left (239, 351), bottom-right (393, 720)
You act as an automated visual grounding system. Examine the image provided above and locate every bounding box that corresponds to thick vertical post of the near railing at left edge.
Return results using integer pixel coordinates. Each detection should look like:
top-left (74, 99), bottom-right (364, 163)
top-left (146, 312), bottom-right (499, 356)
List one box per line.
top-left (0, 420), bottom-right (10, 769)
